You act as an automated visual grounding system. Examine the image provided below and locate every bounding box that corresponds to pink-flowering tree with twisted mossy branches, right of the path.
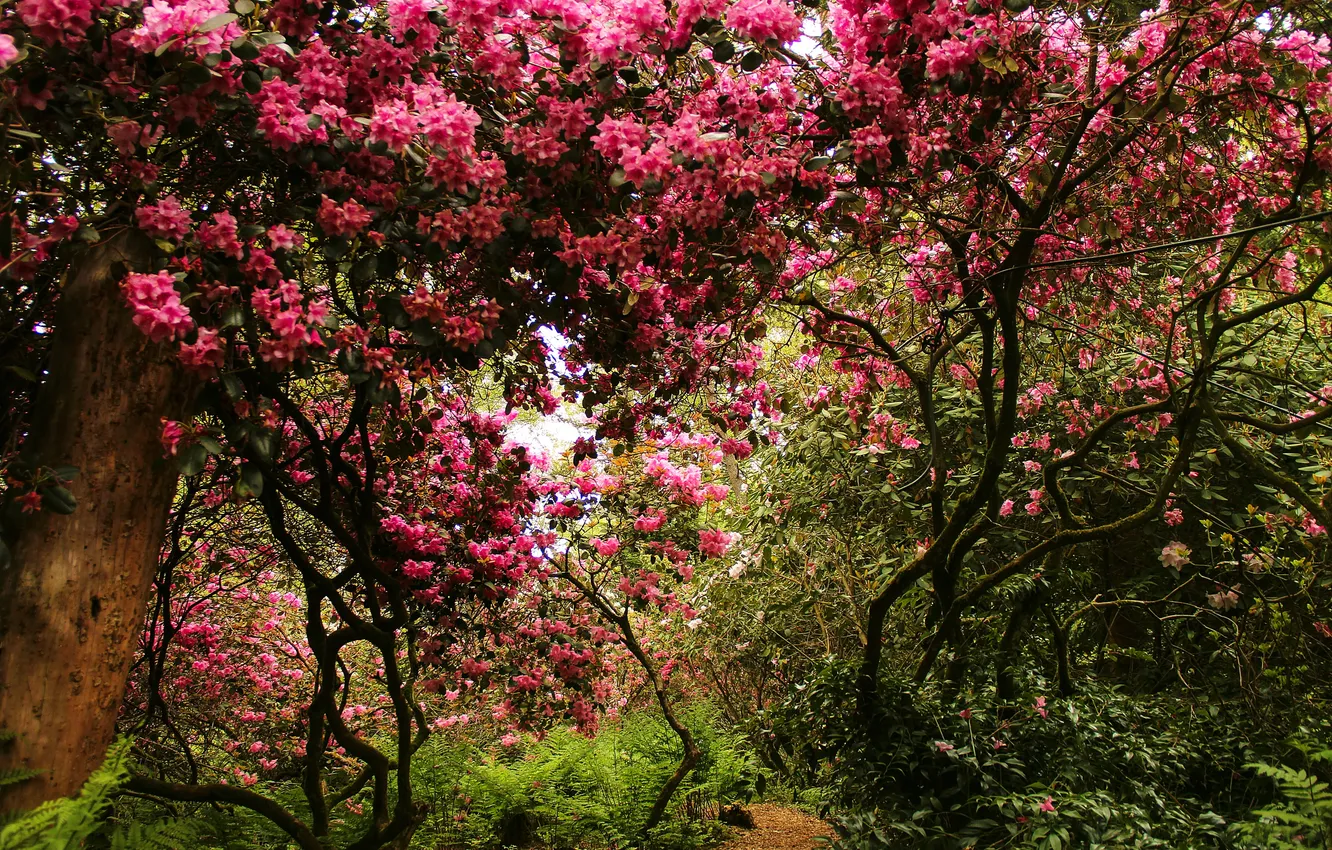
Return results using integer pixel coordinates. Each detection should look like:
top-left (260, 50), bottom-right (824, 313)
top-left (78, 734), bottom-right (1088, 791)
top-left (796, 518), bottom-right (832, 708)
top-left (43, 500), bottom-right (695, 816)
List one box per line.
top-left (761, 3), bottom-right (1332, 710)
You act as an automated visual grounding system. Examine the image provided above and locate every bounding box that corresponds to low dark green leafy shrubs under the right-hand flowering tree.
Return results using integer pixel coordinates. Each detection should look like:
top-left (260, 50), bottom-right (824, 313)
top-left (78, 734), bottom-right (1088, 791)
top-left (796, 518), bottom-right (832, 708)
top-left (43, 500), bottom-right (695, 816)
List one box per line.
top-left (769, 663), bottom-right (1332, 850)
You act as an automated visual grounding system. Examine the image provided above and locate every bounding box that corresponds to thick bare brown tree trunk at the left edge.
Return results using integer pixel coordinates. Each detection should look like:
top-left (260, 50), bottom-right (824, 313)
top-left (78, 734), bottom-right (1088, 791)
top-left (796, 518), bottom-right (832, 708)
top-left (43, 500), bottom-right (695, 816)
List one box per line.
top-left (0, 232), bottom-right (192, 811)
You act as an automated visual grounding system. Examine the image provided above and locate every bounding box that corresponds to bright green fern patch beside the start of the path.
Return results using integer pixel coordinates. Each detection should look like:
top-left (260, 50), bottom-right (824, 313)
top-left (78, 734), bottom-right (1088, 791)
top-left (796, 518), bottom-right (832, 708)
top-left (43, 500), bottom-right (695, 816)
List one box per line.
top-left (413, 703), bottom-right (763, 850)
